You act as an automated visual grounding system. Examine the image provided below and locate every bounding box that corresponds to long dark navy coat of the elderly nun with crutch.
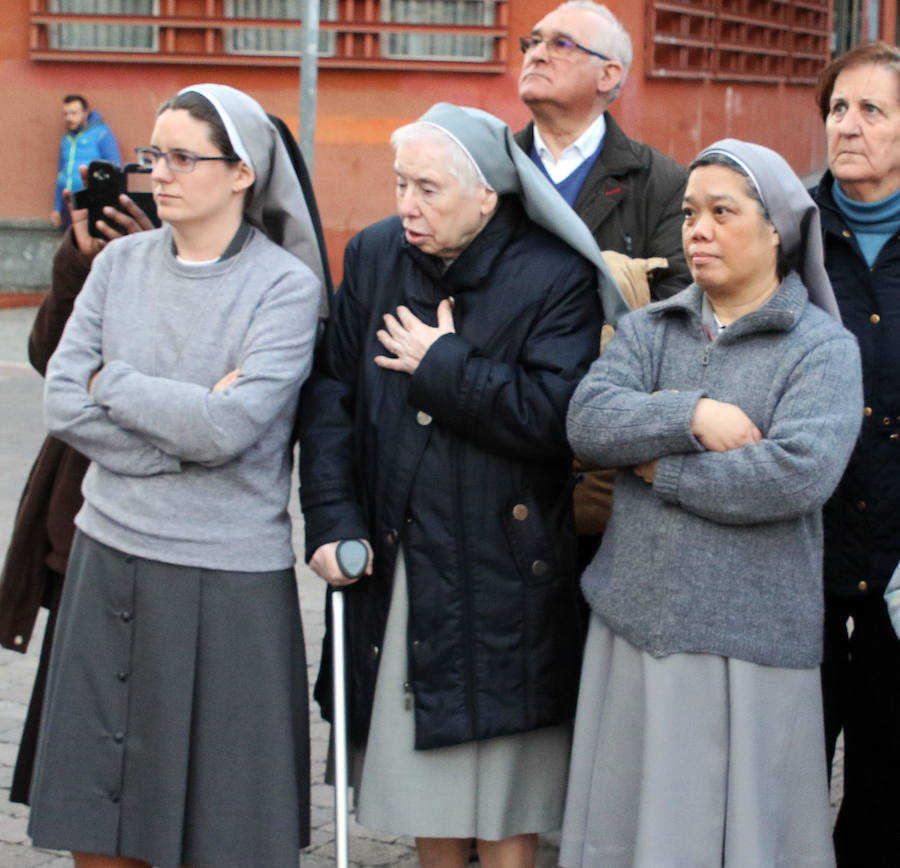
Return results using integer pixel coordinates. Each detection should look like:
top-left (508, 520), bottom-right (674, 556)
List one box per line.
top-left (300, 199), bottom-right (603, 749)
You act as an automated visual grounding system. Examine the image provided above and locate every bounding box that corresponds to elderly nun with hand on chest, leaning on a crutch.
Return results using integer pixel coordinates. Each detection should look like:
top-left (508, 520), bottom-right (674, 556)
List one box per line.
top-left (301, 104), bottom-right (624, 868)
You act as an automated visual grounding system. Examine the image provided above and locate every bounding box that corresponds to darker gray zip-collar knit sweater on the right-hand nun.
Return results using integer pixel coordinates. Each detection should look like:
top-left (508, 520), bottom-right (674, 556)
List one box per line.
top-left (568, 274), bottom-right (862, 668)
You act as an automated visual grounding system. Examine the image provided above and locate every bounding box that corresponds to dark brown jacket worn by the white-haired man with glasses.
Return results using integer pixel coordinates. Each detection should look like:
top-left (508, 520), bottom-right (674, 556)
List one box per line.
top-left (516, 112), bottom-right (691, 300)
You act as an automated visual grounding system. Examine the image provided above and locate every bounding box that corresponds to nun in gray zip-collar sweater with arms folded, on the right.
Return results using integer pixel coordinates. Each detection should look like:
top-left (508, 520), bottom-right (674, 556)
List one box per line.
top-left (560, 139), bottom-right (862, 868)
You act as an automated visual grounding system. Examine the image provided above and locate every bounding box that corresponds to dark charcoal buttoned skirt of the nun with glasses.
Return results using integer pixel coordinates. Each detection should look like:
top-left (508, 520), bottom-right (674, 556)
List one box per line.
top-left (29, 533), bottom-right (309, 868)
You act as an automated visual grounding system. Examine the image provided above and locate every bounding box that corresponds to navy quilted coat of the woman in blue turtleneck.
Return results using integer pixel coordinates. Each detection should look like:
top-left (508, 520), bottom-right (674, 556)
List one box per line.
top-left (811, 172), bottom-right (900, 596)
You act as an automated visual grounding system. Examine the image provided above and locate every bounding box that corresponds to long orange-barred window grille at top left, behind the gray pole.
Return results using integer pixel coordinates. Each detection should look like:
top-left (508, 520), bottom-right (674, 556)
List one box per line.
top-left (29, 0), bottom-right (509, 73)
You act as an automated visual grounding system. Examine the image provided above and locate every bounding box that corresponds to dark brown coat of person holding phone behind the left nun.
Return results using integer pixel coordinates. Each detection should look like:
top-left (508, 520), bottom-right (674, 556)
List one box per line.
top-left (0, 230), bottom-right (90, 652)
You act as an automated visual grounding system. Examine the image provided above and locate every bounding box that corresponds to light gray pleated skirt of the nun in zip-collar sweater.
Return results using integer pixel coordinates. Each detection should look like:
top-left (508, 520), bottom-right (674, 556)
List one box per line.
top-left (559, 615), bottom-right (834, 868)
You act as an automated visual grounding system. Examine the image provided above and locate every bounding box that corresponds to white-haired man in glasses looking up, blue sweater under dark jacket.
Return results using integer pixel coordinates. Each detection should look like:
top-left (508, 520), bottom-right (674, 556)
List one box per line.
top-left (516, 0), bottom-right (690, 299)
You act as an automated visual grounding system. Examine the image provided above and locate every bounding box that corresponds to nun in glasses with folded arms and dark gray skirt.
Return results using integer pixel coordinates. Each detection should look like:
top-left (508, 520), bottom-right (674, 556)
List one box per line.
top-left (29, 84), bottom-right (324, 868)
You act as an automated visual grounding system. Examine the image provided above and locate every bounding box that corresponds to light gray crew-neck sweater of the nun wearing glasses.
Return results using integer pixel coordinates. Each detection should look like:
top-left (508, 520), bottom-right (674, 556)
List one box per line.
top-left (45, 228), bottom-right (320, 571)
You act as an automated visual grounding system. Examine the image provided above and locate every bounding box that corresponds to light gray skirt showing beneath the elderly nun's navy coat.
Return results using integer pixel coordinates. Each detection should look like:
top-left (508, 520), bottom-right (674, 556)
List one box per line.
top-left (357, 558), bottom-right (572, 841)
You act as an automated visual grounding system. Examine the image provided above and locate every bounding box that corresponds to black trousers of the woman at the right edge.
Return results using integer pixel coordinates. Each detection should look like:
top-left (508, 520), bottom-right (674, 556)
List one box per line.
top-left (822, 594), bottom-right (900, 868)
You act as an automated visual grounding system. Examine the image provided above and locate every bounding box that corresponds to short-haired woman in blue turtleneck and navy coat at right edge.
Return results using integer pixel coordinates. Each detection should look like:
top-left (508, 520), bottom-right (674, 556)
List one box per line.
top-left (811, 42), bottom-right (900, 868)
